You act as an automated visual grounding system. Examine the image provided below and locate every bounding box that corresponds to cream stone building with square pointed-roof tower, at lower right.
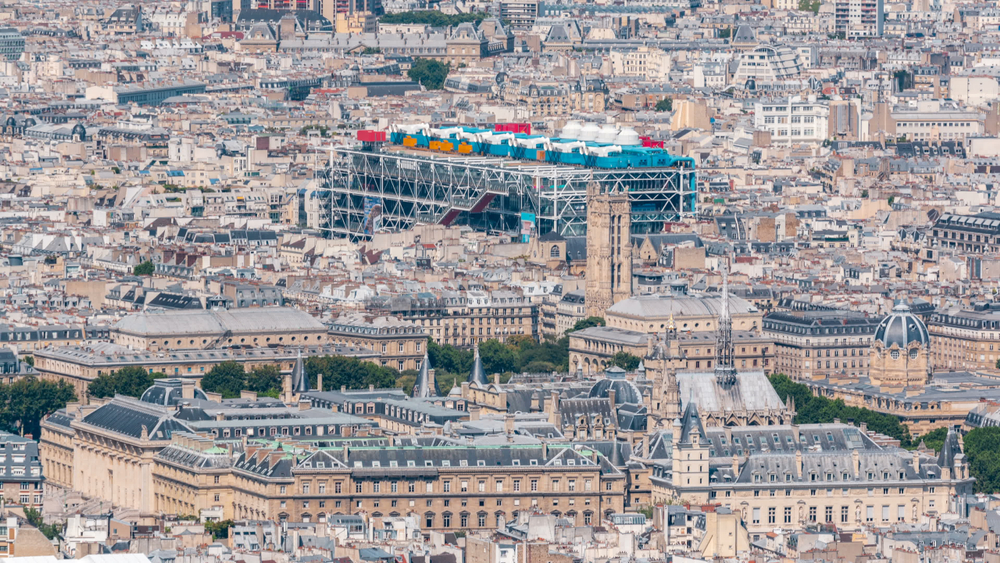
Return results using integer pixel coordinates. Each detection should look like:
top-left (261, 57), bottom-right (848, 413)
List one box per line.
top-left (652, 404), bottom-right (974, 539)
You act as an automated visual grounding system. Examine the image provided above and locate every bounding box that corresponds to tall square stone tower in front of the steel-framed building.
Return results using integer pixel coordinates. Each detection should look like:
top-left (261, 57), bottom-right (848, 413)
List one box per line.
top-left (585, 182), bottom-right (632, 317)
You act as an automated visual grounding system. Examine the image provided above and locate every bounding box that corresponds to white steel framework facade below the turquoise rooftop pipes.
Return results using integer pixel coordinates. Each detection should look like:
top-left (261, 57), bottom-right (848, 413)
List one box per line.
top-left (320, 149), bottom-right (696, 239)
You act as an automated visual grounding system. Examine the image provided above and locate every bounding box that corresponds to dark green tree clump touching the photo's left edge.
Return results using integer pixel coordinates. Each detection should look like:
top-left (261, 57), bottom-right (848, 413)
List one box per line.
top-left (0, 377), bottom-right (76, 437)
